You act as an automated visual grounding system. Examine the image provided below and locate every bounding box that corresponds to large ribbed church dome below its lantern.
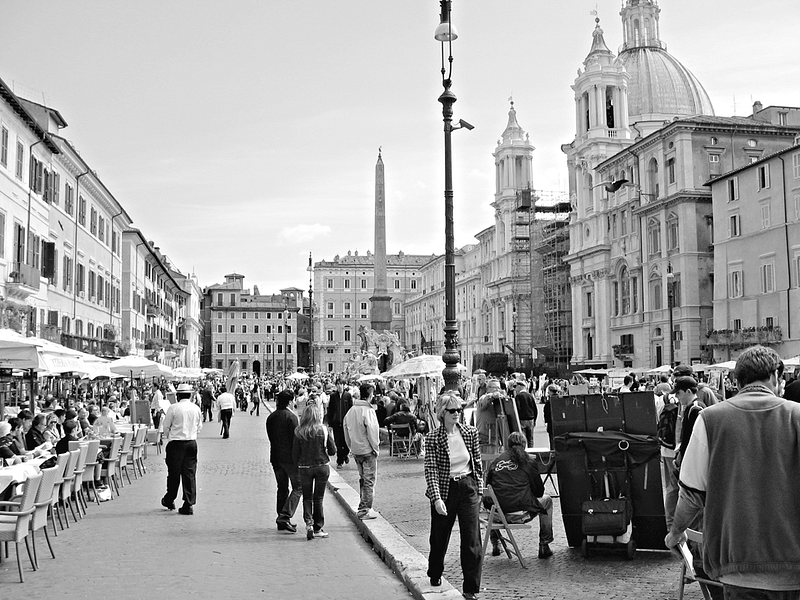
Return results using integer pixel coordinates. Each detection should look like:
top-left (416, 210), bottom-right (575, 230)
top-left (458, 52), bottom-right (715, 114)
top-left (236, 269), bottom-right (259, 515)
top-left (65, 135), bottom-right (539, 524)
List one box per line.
top-left (617, 46), bottom-right (714, 123)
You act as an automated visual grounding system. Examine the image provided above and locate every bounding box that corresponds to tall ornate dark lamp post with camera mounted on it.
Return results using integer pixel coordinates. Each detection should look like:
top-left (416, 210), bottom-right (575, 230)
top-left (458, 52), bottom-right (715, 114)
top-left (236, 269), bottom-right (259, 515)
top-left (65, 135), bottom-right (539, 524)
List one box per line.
top-left (433, 0), bottom-right (473, 390)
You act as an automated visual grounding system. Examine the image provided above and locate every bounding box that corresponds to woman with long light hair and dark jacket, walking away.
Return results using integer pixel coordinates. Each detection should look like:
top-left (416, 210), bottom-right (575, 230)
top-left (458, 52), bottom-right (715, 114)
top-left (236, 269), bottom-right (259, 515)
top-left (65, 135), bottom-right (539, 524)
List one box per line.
top-left (292, 406), bottom-right (336, 540)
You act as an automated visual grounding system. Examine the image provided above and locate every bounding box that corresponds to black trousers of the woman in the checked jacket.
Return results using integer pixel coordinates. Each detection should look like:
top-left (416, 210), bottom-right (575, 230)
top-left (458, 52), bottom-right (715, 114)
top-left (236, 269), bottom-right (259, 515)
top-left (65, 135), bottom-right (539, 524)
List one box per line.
top-left (428, 476), bottom-right (483, 594)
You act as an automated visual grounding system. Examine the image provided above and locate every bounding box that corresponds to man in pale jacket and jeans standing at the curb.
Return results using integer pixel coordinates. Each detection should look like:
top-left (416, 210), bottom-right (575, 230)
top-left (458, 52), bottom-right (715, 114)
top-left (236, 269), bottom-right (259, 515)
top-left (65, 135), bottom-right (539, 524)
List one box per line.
top-left (344, 383), bottom-right (380, 519)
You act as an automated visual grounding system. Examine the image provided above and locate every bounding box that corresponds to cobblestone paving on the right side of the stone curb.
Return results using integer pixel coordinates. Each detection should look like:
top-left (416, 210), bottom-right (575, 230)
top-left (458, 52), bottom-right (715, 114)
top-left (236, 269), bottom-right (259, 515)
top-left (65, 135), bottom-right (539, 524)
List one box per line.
top-left (338, 426), bottom-right (702, 600)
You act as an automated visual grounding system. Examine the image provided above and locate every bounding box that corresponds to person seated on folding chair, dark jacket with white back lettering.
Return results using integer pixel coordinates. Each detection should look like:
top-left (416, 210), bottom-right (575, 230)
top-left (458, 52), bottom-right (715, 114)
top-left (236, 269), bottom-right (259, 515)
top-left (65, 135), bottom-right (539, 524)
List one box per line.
top-left (484, 431), bottom-right (553, 558)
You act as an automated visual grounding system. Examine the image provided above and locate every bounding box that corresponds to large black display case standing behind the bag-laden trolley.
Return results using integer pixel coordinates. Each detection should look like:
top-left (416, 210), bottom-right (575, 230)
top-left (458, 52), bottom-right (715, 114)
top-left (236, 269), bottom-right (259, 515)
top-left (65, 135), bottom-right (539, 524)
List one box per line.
top-left (551, 392), bottom-right (667, 550)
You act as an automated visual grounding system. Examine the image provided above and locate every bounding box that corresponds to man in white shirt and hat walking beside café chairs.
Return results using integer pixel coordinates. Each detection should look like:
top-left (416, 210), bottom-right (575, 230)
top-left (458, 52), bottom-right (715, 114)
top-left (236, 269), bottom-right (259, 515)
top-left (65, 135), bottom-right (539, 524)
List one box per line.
top-left (161, 383), bottom-right (203, 515)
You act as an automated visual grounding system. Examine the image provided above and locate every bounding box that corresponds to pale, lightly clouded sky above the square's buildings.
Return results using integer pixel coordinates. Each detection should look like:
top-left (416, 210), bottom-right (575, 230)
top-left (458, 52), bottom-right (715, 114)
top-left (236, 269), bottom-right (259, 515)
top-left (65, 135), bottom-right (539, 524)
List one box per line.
top-left (0, 0), bottom-right (800, 293)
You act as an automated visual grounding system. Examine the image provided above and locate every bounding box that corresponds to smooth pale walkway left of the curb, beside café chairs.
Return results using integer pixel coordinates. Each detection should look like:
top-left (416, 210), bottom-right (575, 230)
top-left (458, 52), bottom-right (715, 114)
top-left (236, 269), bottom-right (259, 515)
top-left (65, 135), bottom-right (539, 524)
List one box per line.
top-left (0, 412), bottom-right (409, 600)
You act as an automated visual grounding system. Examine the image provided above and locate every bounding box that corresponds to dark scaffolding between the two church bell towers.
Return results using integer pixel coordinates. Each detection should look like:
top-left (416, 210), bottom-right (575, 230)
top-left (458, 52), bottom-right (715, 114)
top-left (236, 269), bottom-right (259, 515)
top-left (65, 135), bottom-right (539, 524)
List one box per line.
top-left (532, 192), bottom-right (572, 374)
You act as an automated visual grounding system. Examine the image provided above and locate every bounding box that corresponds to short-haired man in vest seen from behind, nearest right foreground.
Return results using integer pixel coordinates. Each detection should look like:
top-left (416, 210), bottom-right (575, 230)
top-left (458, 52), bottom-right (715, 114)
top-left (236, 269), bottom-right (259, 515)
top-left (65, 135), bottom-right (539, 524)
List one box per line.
top-left (664, 346), bottom-right (800, 600)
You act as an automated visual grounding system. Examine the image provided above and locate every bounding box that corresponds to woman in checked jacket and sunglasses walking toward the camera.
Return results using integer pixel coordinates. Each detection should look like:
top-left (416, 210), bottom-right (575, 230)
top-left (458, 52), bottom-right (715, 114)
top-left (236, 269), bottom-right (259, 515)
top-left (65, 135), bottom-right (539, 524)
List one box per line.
top-left (425, 393), bottom-right (483, 599)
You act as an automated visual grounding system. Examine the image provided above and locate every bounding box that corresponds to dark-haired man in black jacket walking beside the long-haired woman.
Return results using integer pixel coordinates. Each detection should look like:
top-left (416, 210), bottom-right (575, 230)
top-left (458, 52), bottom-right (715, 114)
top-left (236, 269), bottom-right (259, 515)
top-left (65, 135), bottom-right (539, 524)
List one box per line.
top-left (267, 389), bottom-right (303, 533)
